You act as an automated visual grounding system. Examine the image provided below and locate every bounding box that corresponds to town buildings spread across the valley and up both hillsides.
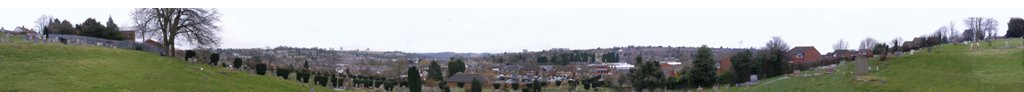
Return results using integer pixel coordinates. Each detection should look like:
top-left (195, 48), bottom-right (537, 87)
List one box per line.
top-left (0, 25), bottom-right (924, 89)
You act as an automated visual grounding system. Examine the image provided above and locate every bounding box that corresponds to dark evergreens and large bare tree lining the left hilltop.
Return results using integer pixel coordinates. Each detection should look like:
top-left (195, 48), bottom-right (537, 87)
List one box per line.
top-left (36, 8), bottom-right (228, 56)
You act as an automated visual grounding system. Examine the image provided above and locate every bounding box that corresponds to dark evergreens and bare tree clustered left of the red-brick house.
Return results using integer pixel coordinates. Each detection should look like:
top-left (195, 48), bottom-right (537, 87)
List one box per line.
top-left (628, 37), bottom-right (794, 91)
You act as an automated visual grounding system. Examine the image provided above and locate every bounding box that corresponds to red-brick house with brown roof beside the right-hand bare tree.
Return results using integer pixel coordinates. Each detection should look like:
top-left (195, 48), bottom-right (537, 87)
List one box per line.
top-left (786, 46), bottom-right (821, 63)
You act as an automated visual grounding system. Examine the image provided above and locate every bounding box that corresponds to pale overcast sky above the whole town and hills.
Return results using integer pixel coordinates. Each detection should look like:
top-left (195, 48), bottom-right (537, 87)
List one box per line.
top-left (0, 8), bottom-right (1024, 54)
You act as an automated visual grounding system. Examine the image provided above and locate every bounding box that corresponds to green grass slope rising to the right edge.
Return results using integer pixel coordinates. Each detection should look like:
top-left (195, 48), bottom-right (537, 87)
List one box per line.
top-left (727, 40), bottom-right (1024, 92)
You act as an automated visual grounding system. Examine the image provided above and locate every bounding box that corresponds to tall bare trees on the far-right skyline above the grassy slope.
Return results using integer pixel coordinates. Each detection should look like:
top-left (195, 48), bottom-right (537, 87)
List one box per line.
top-left (964, 17), bottom-right (999, 40)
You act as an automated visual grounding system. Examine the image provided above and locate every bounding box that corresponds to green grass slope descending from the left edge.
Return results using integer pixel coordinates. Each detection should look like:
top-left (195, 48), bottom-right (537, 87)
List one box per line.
top-left (0, 34), bottom-right (348, 92)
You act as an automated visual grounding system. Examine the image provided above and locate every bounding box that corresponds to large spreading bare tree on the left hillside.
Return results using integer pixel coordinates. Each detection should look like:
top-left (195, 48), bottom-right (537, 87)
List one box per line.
top-left (132, 8), bottom-right (220, 56)
